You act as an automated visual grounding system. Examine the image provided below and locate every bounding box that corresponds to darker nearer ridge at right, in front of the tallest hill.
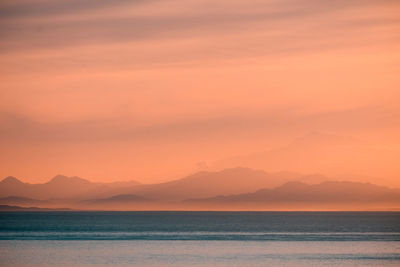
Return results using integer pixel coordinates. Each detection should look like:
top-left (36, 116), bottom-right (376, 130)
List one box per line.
top-left (185, 181), bottom-right (400, 208)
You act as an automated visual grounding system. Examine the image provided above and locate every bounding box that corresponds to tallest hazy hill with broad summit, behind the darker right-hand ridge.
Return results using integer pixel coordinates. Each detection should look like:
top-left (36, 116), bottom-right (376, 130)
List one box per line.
top-left (114, 168), bottom-right (327, 200)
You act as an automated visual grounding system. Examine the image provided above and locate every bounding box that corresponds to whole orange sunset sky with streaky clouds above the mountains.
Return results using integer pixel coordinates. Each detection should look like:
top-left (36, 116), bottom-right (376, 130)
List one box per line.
top-left (0, 0), bottom-right (400, 187)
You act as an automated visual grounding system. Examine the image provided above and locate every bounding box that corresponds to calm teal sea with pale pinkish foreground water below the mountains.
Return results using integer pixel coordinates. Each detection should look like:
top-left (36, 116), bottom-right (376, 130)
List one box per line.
top-left (0, 211), bottom-right (400, 266)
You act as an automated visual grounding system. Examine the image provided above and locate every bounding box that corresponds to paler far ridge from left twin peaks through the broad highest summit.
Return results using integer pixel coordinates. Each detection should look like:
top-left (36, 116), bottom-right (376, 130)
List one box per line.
top-left (0, 168), bottom-right (327, 201)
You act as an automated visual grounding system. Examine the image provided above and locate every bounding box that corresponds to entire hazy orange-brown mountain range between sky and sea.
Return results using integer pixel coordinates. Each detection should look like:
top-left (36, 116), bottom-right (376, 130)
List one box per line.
top-left (0, 168), bottom-right (400, 210)
